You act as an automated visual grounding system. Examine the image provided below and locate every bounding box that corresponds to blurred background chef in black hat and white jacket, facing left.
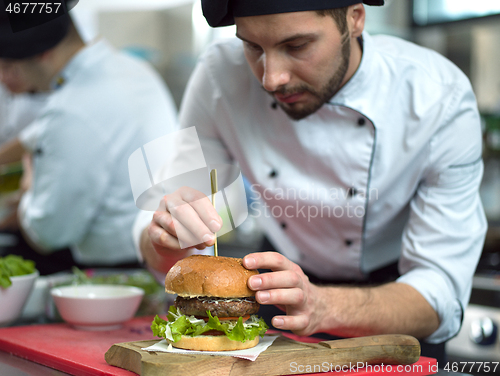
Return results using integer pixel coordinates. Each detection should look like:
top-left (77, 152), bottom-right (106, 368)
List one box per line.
top-left (0, 4), bottom-right (177, 273)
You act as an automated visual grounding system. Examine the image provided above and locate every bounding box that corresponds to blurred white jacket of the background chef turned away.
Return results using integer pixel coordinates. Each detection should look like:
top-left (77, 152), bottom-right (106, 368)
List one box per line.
top-left (19, 40), bottom-right (177, 265)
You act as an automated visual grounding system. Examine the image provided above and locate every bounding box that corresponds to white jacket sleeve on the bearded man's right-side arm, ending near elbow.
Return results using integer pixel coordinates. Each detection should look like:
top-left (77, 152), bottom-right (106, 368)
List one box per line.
top-left (398, 80), bottom-right (487, 343)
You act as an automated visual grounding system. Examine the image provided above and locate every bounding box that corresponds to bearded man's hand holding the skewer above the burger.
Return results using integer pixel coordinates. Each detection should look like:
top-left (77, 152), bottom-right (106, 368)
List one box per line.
top-left (148, 187), bottom-right (222, 254)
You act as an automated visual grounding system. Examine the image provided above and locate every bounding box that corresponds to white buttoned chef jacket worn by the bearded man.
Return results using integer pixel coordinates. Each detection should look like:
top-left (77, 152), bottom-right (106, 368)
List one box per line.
top-left (170, 32), bottom-right (486, 343)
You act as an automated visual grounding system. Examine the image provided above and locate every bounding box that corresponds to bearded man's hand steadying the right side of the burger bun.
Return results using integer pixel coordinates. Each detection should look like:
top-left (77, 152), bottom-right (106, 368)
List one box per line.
top-left (243, 252), bottom-right (322, 336)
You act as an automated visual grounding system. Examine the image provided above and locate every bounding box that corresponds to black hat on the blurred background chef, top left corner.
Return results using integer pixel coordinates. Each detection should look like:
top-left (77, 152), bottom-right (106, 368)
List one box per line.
top-left (0, 0), bottom-right (76, 59)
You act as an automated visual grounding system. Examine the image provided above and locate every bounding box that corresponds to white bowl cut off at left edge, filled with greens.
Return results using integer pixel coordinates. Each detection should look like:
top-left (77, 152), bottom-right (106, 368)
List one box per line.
top-left (0, 271), bottom-right (39, 326)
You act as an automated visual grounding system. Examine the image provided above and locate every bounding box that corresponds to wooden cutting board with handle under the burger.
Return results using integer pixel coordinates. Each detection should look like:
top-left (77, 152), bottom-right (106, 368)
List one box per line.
top-left (105, 335), bottom-right (435, 376)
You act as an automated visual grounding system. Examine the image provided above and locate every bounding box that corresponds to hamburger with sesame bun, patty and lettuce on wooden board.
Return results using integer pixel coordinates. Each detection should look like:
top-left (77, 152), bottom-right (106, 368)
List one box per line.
top-left (151, 255), bottom-right (268, 351)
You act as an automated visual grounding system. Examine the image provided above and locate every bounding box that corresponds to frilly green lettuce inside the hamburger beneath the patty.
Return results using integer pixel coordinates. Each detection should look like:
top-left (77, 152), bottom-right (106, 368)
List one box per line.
top-left (151, 306), bottom-right (269, 342)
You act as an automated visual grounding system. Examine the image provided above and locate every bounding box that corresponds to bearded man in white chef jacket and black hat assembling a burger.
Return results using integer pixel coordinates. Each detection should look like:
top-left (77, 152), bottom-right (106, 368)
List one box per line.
top-left (137, 0), bottom-right (486, 360)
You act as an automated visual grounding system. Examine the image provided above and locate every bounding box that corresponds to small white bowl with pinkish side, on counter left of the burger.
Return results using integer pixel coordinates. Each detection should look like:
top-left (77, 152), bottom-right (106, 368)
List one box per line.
top-left (50, 285), bottom-right (144, 330)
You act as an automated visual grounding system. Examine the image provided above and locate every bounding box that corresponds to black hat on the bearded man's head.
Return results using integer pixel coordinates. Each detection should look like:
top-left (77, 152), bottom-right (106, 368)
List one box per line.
top-left (201, 0), bottom-right (384, 27)
